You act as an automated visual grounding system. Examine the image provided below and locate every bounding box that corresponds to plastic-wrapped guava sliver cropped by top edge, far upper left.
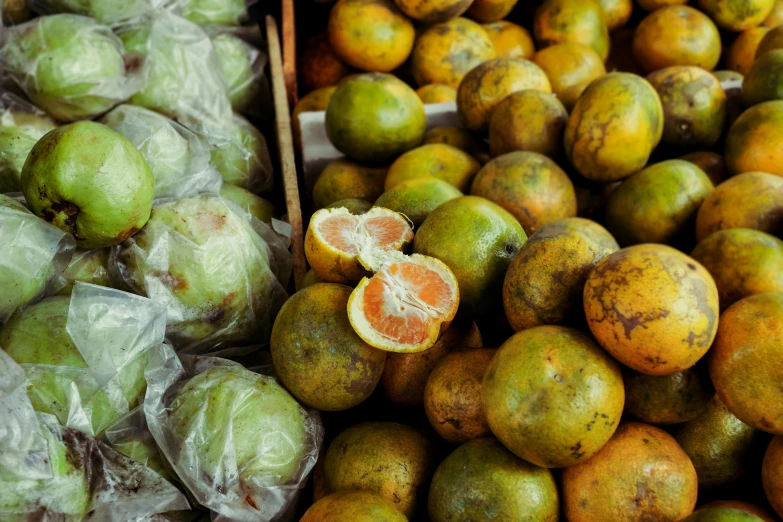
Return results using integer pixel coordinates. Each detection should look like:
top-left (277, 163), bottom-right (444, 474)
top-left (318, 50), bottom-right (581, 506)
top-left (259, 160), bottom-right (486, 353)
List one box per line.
top-left (28, 0), bottom-right (181, 24)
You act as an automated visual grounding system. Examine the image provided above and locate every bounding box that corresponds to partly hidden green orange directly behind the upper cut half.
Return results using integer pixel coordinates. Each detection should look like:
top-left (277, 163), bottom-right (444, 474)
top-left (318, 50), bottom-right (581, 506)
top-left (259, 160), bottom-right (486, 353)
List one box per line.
top-left (375, 178), bottom-right (462, 228)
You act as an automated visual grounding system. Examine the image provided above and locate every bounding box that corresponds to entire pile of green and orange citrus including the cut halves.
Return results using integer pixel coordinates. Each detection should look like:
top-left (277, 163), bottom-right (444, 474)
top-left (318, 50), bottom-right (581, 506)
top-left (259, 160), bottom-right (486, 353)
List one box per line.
top-left (290, 0), bottom-right (783, 522)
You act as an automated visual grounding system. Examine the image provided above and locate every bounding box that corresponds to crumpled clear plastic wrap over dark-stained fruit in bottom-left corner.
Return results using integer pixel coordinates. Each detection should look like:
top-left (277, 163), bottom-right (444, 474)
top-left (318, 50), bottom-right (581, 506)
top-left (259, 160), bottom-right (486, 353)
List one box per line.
top-left (0, 350), bottom-right (189, 522)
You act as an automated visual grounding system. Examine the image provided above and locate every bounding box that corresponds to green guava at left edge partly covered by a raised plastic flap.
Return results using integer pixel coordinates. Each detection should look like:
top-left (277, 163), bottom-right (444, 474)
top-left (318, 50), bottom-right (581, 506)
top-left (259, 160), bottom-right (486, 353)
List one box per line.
top-left (0, 296), bottom-right (149, 434)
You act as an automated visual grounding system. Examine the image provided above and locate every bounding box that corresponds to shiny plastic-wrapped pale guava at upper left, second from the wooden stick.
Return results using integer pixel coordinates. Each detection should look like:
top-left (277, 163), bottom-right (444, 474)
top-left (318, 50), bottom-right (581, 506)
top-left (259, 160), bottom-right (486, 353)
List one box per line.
top-left (115, 9), bottom-right (232, 147)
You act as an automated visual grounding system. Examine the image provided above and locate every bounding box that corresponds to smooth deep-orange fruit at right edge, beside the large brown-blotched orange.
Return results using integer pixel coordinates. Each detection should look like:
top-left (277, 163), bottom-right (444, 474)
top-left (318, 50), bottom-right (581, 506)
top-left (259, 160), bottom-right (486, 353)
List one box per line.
top-left (708, 292), bottom-right (783, 434)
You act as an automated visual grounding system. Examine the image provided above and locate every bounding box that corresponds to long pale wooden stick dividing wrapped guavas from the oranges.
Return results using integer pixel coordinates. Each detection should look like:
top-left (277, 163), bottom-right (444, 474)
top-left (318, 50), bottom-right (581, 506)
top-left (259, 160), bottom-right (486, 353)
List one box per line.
top-left (266, 16), bottom-right (307, 290)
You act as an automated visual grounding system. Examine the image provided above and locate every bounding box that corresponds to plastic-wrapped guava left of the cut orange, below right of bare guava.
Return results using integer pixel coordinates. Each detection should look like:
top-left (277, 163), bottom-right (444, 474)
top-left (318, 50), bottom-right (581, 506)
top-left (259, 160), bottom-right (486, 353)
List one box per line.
top-left (110, 195), bottom-right (292, 353)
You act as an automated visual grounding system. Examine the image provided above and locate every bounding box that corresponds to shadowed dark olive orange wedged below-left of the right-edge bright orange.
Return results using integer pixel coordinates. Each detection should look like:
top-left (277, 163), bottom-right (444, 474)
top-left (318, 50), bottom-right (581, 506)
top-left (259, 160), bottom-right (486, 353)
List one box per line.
top-left (675, 396), bottom-right (759, 488)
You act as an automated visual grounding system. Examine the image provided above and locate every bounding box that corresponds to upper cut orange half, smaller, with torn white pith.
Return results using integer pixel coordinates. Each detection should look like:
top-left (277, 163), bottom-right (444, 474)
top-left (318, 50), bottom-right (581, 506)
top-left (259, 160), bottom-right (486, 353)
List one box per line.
top-left (305, 207), bottom-right (413, 283)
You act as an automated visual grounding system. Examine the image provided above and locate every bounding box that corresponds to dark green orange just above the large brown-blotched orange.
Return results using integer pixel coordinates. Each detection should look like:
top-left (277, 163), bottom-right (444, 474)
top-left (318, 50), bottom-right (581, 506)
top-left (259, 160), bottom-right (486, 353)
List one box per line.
top-left (606, 160), bottom-right (714, 246)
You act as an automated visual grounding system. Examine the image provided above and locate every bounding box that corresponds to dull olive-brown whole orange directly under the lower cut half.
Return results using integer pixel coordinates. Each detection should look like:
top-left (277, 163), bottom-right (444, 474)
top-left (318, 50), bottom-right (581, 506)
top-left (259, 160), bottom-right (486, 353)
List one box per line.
top-left (270, 283), bottom-right (386, 411)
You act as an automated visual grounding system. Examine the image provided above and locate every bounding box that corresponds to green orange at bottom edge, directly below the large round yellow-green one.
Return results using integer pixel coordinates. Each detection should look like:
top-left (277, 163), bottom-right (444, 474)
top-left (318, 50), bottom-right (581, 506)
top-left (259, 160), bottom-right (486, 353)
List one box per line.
top-left (429, 438), bottom-right (558, 522)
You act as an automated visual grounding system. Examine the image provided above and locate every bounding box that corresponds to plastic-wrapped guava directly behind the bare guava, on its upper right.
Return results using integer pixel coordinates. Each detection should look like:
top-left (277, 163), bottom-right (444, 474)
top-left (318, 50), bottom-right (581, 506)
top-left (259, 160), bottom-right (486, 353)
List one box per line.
top-left (101, 105), bottom-right (223, 199)
